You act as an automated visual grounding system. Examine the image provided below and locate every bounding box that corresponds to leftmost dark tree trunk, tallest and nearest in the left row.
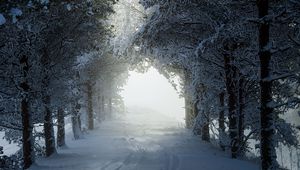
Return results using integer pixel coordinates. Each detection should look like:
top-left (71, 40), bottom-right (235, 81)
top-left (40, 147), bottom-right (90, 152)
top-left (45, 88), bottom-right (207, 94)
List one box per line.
top-left (20, 56), bottom-right (34, 169)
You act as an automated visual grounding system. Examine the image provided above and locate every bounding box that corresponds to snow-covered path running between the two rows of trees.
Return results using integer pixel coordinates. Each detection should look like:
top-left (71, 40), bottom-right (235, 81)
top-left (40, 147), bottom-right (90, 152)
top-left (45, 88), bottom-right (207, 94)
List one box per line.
top-left (31, 115), bottom-right (259, 170)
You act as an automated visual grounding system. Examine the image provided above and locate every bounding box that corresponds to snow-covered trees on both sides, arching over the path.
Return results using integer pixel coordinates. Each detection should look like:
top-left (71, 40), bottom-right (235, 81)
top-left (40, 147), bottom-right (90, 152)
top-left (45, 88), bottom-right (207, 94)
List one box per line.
top-left (0, 0), bottom-right (300, 170)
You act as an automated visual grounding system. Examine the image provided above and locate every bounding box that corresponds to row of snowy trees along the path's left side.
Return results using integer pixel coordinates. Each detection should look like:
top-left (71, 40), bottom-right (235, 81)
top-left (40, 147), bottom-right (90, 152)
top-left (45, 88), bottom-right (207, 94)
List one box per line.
top-left (0, 0), bottom-right (126, 169)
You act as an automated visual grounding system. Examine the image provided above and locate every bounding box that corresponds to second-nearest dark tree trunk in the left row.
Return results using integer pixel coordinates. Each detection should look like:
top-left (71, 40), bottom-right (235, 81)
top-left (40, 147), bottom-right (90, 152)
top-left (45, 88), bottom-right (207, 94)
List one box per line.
top-left (44, 95), bottom-right (55, 157)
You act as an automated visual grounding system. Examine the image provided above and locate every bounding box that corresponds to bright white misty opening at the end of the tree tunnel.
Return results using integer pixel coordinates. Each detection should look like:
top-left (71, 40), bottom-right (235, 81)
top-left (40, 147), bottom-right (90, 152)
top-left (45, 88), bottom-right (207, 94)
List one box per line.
top-left (122, 68), bottom-right (184, 122)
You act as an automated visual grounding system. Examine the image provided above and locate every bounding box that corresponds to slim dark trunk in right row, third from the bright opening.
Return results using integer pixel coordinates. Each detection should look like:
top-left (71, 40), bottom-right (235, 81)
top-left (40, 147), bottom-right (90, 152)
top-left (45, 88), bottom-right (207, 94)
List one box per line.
top-left (219, 92), bottom-right (225, 151)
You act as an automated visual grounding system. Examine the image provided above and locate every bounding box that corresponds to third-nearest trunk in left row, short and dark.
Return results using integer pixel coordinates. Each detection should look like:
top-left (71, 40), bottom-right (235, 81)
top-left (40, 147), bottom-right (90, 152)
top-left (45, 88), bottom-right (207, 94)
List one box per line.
top-left (57, 108), bottom-right (66, 147)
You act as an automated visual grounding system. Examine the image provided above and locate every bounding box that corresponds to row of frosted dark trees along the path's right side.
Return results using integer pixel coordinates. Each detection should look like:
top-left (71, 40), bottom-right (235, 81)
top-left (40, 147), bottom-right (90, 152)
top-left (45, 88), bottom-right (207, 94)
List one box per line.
top-left (132, 0), bottom-right (300, 170)
